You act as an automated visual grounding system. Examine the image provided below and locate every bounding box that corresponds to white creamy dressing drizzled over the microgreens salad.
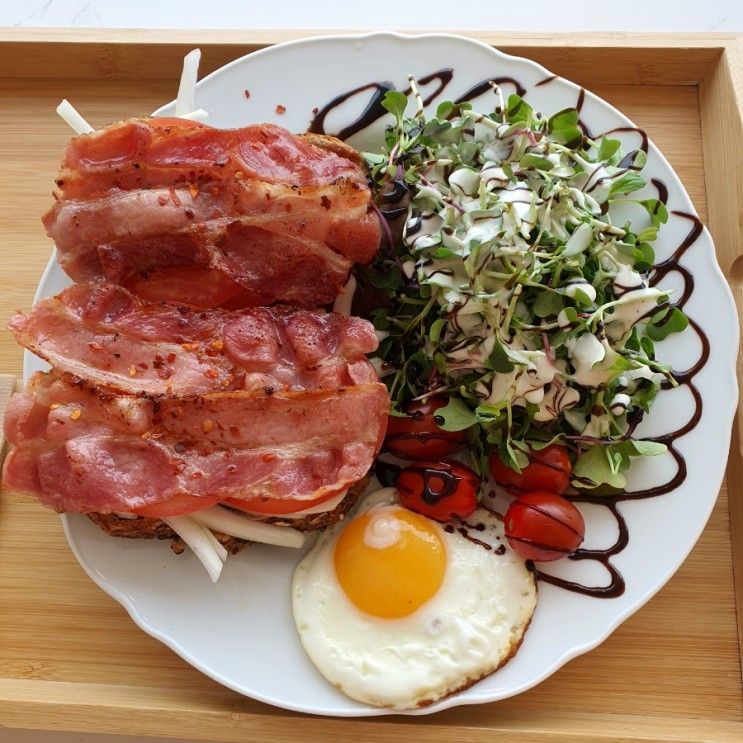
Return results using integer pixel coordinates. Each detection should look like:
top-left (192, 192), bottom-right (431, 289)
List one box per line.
top-left (396, 106), bottom-right (667, 442)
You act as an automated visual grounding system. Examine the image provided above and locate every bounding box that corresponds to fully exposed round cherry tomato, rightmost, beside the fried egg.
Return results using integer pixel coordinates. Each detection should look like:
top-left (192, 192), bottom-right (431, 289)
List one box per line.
top-left (505, 490), bottom-right (586, 561)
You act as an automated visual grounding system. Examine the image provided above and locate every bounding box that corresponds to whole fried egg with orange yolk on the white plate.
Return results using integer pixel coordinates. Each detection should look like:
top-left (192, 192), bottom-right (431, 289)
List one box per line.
top-left (292, 488), bottom-right (537, 710)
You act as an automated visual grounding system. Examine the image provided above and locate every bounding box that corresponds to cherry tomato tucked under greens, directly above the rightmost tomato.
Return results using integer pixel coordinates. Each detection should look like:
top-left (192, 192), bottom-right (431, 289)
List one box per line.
top-left (490, 444), bottom-right (573, 495)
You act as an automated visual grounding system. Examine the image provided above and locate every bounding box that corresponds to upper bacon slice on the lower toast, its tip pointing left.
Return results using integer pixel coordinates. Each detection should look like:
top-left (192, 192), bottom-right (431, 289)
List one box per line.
top-left (8, 282), bottom-right (384, 397)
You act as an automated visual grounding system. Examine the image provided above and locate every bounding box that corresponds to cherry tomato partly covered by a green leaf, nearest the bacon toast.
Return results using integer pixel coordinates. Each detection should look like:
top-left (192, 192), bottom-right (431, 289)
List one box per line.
top-left (385, 395), bottom-right (466, 459)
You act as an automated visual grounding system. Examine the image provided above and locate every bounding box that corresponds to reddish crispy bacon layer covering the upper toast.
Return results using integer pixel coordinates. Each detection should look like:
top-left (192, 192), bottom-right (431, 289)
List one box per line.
top-left (43, 119), bottom-right (381, 307)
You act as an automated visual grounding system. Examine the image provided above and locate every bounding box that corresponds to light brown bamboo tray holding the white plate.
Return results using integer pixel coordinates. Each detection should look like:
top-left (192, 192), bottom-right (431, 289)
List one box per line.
top-left (0, 30), bottom-right (743, 743)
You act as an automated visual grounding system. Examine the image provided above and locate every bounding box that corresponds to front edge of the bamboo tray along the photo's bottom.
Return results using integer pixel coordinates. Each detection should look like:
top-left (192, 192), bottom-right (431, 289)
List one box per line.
top-left (0, 679), bottom-right (743, 743)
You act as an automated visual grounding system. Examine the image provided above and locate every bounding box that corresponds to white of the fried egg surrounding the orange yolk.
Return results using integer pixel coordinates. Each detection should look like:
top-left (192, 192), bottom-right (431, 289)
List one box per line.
top-left (292, 488), bottom-right (536, 710)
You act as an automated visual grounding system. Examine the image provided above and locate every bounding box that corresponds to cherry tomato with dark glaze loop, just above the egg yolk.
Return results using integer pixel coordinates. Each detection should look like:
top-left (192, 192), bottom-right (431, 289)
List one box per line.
top-left (396, 459), bottom-right (480, 521)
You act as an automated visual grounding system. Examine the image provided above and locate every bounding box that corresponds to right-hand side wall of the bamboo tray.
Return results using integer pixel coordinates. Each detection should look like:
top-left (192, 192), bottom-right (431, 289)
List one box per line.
top-left (700, 39), bottom-right (743, 680)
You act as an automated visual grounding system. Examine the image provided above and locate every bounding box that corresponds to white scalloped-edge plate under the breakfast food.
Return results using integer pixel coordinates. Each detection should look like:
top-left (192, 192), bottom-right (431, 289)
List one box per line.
top-left (25, 33), bottom-right (738, 716)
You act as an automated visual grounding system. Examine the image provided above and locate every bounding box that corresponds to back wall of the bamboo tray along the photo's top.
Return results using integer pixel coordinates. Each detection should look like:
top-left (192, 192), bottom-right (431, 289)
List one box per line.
top-left (0, 29), bottom-right (735, 86)
